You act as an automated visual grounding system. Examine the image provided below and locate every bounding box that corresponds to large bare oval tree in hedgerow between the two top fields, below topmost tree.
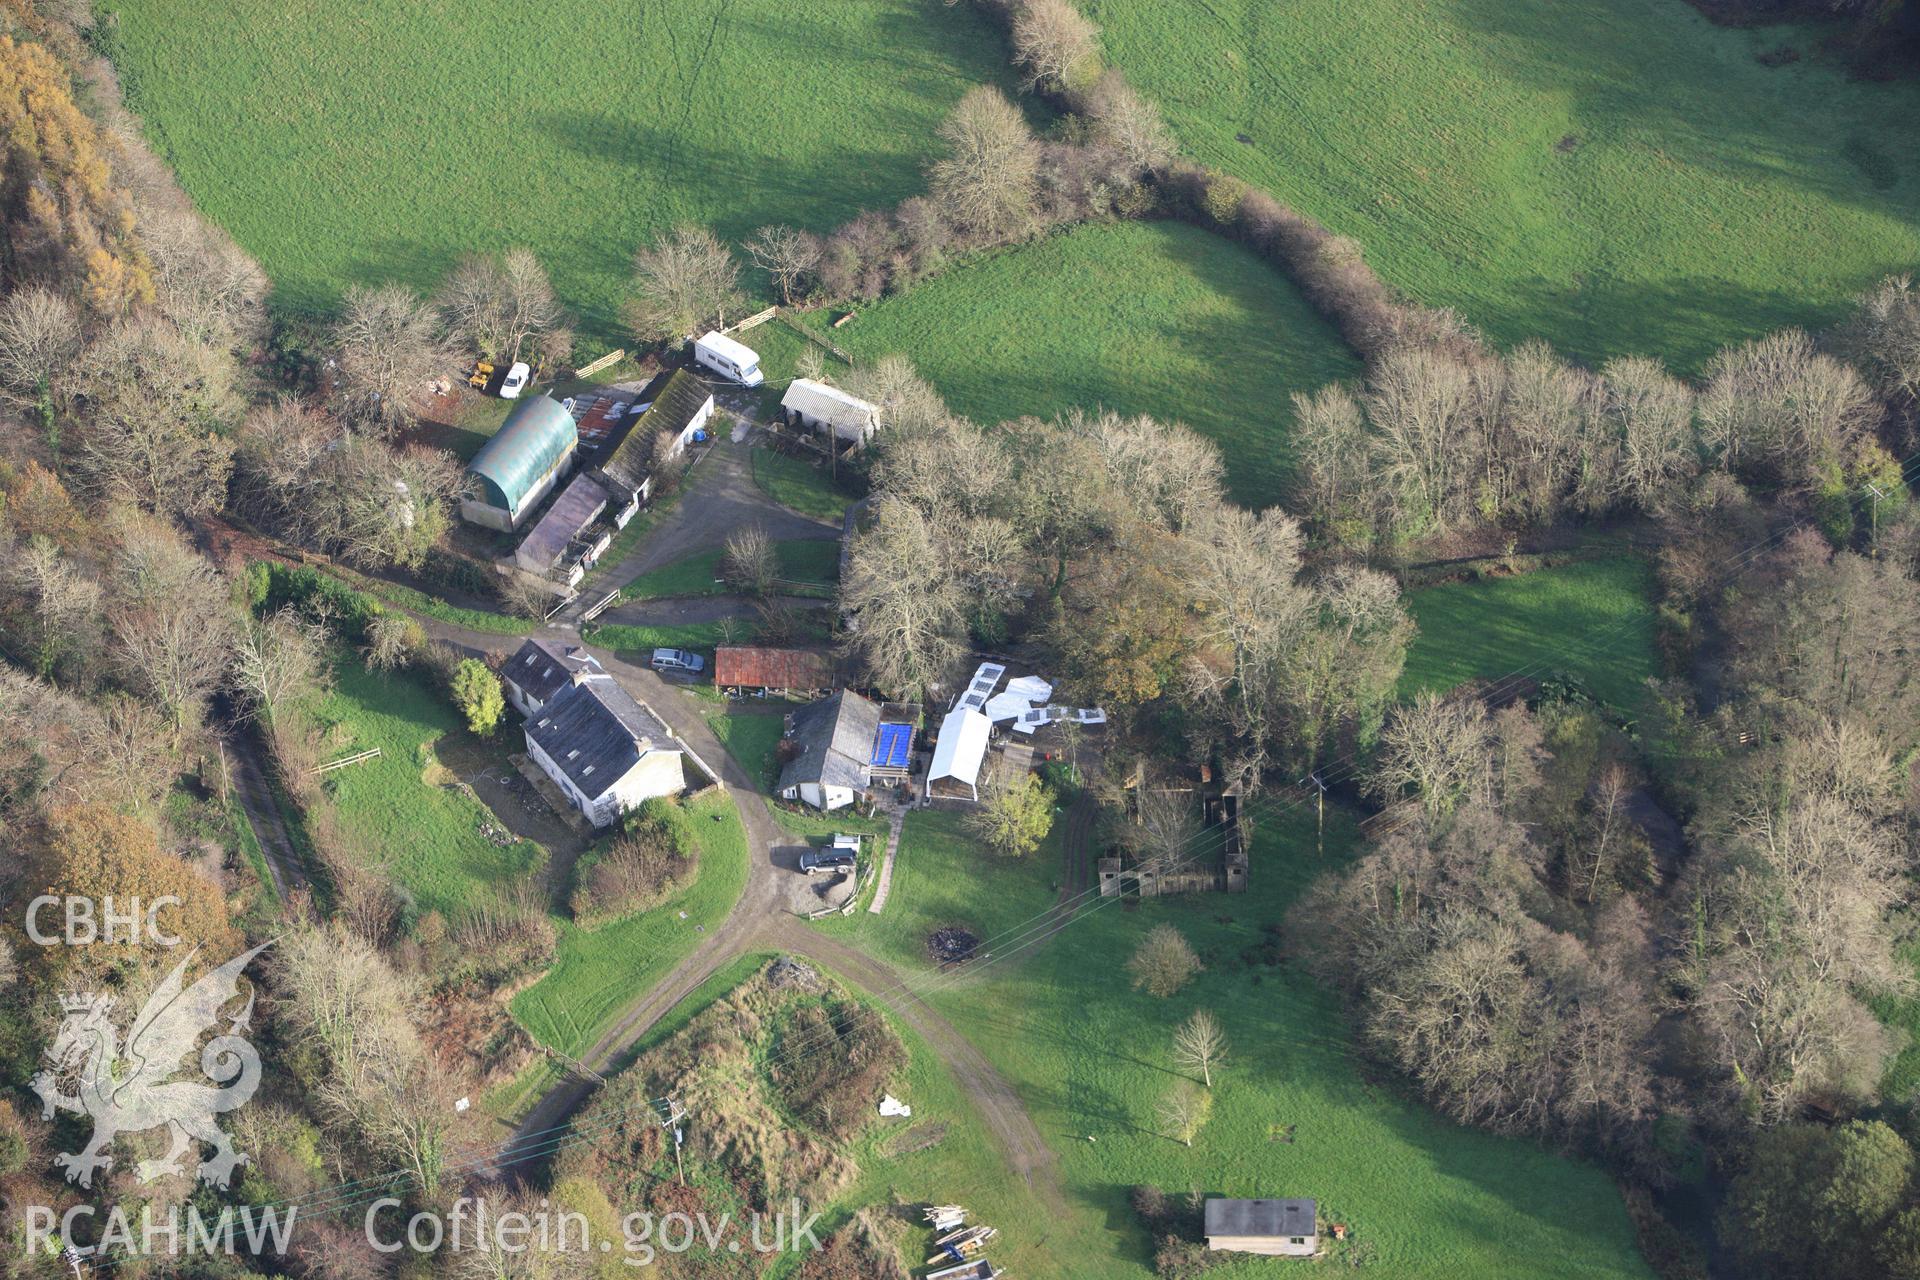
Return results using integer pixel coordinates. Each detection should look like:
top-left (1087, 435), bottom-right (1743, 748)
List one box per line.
top-left (929, 84), bottom-right (1039, 240)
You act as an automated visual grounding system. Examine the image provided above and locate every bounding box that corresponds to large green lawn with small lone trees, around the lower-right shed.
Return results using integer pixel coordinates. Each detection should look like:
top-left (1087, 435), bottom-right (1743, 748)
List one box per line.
top-left (816, 812), bottom-right (1651, 1280)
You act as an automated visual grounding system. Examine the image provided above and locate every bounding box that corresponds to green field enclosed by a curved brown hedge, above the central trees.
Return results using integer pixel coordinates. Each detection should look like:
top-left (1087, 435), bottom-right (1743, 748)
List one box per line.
top-left (817, 223), bottom-right (1359, 507)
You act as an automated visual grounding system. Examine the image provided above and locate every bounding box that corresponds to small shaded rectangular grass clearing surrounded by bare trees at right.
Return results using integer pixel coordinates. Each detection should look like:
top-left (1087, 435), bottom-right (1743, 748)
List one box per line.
top-left (1400, 557), bottom-right (1659, 712)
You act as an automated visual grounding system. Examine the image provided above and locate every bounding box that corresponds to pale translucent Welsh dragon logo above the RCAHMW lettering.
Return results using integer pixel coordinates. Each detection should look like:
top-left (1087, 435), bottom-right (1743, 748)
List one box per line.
top-left (33, 942), bottom-right (271, 1188)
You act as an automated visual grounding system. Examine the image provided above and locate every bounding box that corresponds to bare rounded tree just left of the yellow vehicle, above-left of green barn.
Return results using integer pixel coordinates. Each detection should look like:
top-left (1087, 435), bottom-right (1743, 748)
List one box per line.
top-left (334, 284), bottom-right (455, 436)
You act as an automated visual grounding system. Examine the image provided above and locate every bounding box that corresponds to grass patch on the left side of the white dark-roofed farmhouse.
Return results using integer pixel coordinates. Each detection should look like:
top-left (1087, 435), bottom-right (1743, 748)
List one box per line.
top-left (313, 656), bottom-right (545, 912)
